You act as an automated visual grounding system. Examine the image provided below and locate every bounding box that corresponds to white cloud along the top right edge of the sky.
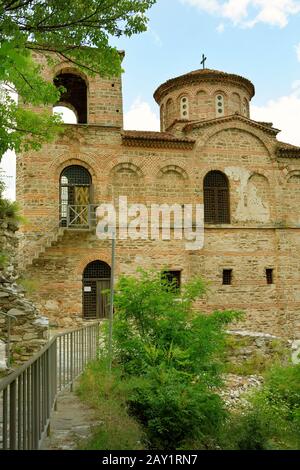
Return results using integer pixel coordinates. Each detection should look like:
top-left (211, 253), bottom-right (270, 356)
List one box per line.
top-left (181, 0), bottom-right (300, 28)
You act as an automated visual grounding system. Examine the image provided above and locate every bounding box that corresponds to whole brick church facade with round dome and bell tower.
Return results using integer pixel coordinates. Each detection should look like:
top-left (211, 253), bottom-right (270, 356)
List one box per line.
top-left (17, 55), bottom-right (300, 338)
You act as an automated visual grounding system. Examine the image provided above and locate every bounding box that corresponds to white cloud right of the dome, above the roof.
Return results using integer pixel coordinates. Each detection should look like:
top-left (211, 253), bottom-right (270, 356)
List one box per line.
top-left (251, 81), bottom-right (300, 146)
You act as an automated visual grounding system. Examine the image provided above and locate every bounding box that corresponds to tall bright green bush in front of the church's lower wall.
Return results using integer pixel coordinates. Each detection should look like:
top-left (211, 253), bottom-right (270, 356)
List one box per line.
top-left (105, 271), bottom-right (241, 449)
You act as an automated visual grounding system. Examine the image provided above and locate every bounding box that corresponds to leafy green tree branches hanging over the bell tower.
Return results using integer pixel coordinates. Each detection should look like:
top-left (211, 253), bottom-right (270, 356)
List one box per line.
top-left (0, 0), bottom-right (156, 155)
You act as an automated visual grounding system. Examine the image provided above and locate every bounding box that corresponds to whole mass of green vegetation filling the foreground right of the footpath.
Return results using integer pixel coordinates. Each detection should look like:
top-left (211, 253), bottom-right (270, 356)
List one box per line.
top-left (78, 271), bottom-right (300, 450)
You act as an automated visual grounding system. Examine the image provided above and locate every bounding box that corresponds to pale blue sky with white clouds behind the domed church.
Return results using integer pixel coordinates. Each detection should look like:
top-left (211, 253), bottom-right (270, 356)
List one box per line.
top-left (1, 0), bottom-right (300, 199)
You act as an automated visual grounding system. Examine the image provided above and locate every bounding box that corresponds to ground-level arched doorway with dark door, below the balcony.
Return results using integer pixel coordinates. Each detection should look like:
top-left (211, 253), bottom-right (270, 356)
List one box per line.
top-left (82, 261), bottom-right (110, 319)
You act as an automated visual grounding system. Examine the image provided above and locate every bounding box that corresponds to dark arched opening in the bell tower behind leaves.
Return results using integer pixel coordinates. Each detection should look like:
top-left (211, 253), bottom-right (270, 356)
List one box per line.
top-left (54, 72), bottom-right (87, 124)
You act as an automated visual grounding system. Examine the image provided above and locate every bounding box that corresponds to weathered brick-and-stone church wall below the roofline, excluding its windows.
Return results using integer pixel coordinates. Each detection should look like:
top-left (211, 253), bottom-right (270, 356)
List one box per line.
top-left (17, 57), bottom-right (300, 338)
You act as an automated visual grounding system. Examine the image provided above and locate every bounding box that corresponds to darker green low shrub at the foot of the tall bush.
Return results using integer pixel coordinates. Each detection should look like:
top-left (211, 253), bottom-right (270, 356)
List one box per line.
top-left (128, 367), bottom-right (226, 450)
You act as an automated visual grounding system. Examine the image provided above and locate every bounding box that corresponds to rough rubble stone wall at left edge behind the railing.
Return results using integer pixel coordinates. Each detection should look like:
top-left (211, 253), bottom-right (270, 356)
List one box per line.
top-left (0, 219), bottom-right (48, 367)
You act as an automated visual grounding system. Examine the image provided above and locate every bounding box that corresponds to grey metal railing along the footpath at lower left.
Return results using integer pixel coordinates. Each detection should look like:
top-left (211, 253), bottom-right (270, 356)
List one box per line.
top-left (0, 322), bottom-right (99, 450)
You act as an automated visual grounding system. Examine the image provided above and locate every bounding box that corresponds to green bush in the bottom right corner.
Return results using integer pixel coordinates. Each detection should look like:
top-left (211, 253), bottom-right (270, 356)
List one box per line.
top-left (222, 365), bottom-right (300, 450)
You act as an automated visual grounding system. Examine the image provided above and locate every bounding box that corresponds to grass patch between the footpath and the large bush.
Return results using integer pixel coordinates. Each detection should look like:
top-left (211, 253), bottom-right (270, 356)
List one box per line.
top-left (76, 360), bottom-right (145, 450)
